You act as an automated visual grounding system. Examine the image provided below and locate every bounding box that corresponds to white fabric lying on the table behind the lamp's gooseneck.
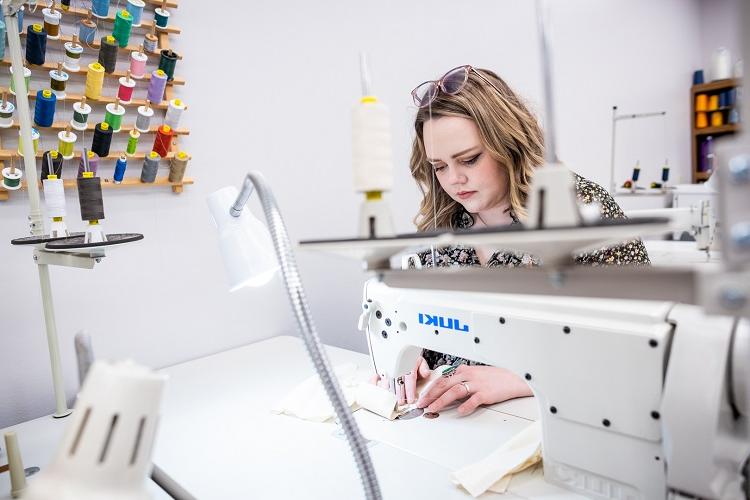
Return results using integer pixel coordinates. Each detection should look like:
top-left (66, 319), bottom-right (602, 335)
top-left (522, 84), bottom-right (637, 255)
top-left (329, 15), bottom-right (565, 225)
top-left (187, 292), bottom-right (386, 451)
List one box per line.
top-left (271, 363), bottom-right (360, 422)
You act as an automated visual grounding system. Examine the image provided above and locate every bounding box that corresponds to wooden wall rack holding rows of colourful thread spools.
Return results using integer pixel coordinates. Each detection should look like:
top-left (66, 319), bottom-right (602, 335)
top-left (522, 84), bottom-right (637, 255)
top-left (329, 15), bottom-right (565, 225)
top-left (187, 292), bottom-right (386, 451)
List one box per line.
top-left (0, 0), bottom-right (189, 201)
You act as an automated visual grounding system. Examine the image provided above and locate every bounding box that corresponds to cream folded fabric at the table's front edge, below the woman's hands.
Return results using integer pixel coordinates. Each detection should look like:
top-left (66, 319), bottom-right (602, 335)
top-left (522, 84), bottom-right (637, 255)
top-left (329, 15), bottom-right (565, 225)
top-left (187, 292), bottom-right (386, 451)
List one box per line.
top-left (452, 422), bottom-right (542, 498)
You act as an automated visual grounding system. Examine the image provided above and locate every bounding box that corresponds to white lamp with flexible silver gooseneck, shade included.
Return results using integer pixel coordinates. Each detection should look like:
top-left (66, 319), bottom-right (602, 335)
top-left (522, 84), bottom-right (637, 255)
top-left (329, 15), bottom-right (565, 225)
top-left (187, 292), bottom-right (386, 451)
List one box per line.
top-left (208, 172), bottom-right (382, 500)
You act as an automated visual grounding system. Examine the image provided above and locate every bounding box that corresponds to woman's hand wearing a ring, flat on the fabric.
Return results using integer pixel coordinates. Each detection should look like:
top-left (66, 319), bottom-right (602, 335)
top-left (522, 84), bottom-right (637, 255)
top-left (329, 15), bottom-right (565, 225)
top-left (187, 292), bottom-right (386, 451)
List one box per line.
top-left (417, 365), bottom-right (532, 416)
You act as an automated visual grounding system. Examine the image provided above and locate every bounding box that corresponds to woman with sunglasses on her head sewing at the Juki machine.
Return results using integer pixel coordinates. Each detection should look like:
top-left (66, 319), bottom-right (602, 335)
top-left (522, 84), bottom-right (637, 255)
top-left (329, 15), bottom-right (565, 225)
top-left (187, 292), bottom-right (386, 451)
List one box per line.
top-left (390, 66), bottom-right (649, 415)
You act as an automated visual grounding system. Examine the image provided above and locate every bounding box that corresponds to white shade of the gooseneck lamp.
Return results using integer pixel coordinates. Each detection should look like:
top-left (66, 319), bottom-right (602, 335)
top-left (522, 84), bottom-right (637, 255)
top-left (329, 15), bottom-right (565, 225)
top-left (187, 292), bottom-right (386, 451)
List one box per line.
top-left (207, 186), bottom-right (279, 291)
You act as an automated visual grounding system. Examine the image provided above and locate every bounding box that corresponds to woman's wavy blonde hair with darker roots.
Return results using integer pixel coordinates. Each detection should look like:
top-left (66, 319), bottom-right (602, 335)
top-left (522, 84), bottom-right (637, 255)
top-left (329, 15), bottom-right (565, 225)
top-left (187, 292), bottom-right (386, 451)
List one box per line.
top-left (409, 68), bottom-right (544, 231)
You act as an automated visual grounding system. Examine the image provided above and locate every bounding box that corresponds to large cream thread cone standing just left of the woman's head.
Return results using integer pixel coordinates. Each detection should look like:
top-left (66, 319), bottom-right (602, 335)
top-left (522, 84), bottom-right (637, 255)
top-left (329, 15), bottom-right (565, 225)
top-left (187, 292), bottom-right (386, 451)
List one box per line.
top-left (352, 98), bottom-right (393, 192)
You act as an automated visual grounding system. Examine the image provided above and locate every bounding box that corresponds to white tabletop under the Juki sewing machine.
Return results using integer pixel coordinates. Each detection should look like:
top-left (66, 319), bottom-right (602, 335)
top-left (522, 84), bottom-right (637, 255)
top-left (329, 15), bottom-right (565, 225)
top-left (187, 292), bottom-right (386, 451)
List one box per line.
top-left (0, 336), bottom-right (583, 500)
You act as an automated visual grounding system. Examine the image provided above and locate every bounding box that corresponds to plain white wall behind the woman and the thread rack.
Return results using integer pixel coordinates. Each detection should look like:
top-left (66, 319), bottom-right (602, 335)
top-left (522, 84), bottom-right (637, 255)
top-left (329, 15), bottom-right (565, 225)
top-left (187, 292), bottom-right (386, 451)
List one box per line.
top-left (0, 0), bottom-right (698, 427)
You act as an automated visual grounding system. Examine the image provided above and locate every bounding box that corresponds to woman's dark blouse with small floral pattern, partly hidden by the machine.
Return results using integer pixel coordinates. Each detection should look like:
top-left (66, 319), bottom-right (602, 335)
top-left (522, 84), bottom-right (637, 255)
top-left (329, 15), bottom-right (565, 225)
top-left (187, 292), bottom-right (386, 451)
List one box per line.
top-left (418, 174), bottom-right (651, 368)
